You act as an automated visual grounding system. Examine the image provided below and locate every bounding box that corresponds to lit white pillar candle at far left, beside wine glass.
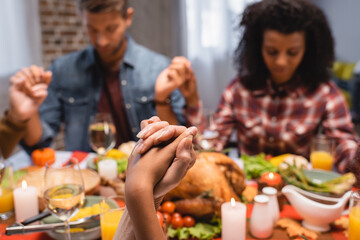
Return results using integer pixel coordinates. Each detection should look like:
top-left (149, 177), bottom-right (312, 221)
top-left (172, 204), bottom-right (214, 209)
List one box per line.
top-left (14, 181), bottom-right (39, 222)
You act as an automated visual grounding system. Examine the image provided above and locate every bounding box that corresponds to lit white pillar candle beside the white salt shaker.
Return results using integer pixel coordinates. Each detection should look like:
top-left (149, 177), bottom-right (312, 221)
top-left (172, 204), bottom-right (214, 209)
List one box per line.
top-left (221, 198), bottom-right (246, 240)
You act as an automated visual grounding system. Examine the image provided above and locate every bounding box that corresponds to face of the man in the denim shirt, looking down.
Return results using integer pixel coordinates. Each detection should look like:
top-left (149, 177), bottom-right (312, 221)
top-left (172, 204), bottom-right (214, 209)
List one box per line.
top-left (82, 8), bottom-right (133, 62)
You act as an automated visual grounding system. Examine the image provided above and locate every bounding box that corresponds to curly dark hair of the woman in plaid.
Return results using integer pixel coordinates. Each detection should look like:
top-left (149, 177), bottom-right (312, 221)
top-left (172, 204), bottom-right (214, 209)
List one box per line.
top-left (234, 0), bottom-right (334, 90)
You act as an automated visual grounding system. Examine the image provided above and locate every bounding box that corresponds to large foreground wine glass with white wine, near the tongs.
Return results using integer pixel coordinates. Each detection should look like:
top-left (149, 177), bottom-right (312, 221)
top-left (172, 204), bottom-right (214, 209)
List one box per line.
top-left (44, 158), bottom-right (85, 240)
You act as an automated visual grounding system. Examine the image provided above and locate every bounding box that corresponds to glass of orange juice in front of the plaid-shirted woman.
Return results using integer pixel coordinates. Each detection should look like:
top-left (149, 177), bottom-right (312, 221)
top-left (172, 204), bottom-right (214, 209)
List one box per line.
top-left (310, 135), bottom-right (335, 171)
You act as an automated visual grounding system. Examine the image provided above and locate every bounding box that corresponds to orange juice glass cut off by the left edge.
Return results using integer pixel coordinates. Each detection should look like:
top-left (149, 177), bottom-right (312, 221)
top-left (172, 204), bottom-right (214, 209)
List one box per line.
top-left (0, 150), bottom-right (14, 220)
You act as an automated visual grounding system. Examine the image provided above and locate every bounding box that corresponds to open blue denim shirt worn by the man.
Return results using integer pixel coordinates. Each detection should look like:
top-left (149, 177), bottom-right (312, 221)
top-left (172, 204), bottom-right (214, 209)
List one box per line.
top-left (23, 36), bottom-right (185, 152)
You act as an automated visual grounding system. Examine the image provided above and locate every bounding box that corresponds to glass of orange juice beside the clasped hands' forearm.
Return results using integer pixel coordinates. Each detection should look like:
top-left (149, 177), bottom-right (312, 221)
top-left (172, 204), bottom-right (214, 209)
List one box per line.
top-left (100, 196), bottom-right (125, 240)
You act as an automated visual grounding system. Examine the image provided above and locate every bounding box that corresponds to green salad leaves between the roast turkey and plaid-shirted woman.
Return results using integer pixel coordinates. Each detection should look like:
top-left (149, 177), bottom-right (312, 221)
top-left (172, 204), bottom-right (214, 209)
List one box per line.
top-left (241, 153), bottom-right (277, 179)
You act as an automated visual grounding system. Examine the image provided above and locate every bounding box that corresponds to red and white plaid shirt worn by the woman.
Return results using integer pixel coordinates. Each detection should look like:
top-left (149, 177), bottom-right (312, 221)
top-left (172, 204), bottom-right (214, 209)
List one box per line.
top-left (185, 79), bottom-right (358, 172)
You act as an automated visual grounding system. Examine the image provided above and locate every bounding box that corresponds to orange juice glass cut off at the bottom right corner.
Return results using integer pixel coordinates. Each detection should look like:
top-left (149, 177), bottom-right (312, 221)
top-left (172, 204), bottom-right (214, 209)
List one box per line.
top-left (349, 191), bottom-right (360, 240)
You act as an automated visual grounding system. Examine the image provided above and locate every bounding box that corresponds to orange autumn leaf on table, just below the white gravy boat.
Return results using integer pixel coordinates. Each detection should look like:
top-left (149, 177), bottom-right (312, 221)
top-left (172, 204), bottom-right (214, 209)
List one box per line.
top-left (276, 218), bottom-right (318, 240)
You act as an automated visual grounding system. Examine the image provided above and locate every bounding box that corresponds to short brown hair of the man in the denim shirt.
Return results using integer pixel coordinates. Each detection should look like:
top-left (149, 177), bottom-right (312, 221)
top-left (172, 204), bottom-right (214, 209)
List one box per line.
top-left (77, 0), bottom-right (129, 18)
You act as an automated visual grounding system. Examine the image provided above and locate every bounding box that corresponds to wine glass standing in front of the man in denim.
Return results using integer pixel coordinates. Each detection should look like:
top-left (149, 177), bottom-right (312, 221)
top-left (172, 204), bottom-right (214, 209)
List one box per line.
top-left (89, 113), bottom-right (116, 155)
